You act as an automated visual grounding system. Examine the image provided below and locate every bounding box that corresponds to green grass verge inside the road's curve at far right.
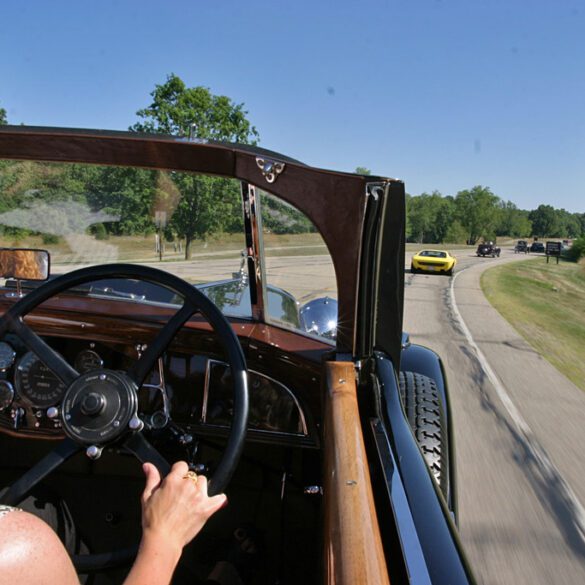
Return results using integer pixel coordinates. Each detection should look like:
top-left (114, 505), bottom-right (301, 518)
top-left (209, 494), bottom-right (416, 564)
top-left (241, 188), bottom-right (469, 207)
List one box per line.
top-left (481, 258), bottom-right (585, 390)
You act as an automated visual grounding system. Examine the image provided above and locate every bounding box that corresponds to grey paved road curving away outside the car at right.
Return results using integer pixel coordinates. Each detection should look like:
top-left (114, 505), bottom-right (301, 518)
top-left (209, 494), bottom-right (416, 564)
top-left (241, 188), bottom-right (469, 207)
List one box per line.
top-left (404, 250), bottom-right (585, 585)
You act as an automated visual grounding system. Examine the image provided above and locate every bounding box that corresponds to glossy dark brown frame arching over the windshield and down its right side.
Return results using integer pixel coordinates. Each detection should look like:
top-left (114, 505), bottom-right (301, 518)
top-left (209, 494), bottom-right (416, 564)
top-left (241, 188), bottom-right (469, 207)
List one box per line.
top-left (0, 126), bottom-right (403, 353)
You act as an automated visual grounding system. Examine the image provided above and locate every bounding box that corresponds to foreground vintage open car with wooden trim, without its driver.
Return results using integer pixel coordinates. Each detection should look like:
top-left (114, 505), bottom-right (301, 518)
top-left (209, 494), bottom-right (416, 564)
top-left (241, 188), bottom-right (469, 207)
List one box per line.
top-left (0, 126), bottom-right (474, 585)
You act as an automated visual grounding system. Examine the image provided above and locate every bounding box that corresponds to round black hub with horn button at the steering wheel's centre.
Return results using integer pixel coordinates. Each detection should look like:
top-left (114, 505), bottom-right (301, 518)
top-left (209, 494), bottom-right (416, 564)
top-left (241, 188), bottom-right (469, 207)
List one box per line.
top-left (63, 370), bottom-right (138, 445)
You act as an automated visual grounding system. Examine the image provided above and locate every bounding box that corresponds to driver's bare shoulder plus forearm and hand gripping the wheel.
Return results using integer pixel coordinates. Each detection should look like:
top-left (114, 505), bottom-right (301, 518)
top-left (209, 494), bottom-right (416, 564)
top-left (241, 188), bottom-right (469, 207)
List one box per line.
top-left (0, 462), bottom-right (227, 585)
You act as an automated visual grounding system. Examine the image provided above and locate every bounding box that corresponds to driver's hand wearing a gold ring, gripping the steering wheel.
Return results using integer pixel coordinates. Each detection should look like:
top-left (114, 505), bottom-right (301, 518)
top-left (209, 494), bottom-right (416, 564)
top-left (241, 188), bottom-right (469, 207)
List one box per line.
top-left (142, 461), bottom-right (227, 550)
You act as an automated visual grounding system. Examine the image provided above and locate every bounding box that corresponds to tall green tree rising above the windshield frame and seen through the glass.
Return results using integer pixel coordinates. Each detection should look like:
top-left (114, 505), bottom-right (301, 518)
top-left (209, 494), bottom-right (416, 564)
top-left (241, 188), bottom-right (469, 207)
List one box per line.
top-left (130, 74), bottom-right (259, 259)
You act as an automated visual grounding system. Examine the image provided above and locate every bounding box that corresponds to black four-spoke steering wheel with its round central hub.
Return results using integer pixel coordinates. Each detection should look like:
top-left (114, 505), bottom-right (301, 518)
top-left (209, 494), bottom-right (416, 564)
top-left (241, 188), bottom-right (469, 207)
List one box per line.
top-left (0, 264), bottom-right (248, 572)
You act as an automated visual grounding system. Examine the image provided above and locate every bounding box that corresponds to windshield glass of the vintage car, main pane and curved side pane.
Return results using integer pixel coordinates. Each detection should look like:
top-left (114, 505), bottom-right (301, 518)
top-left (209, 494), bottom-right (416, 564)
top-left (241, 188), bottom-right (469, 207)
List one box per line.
top-left (0, 161), bottom-right (337, 339)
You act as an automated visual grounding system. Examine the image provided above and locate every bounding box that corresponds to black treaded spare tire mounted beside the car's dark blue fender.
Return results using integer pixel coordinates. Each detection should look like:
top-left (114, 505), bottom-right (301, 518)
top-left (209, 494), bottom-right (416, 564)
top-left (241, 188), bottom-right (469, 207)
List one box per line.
top-left (398, 372), bottom-right (450, 502)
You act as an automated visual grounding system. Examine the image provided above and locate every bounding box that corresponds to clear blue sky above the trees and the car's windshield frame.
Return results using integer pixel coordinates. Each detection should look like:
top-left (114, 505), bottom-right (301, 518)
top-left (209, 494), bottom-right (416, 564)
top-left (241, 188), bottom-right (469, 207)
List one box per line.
top-left (0, 0), bottom-right (585, 212)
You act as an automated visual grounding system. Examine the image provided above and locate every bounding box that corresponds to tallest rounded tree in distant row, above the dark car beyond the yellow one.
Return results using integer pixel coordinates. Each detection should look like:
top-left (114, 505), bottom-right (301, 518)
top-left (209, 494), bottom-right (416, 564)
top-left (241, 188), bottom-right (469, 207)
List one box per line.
top-left (455, 185), bottom-right (500, 243)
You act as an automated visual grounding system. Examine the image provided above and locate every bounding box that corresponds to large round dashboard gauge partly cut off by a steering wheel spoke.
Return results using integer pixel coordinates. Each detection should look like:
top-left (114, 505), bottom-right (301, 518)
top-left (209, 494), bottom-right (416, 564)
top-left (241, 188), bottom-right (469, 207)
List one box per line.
top-left (14, 351), bottom-right (67, 408)
